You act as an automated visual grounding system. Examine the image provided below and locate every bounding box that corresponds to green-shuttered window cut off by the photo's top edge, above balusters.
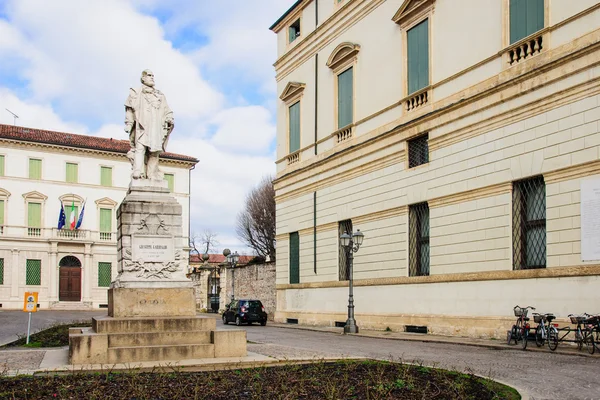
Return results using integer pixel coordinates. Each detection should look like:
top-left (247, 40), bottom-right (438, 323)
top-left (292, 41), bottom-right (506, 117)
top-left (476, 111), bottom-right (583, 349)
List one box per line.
top-left (509, 0), bottom-right (544, 44)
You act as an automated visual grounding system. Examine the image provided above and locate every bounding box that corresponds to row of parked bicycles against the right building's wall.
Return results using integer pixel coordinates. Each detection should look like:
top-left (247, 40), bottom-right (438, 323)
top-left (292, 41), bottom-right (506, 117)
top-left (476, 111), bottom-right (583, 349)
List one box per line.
top-left (506, 306), bottom-right (600, 354)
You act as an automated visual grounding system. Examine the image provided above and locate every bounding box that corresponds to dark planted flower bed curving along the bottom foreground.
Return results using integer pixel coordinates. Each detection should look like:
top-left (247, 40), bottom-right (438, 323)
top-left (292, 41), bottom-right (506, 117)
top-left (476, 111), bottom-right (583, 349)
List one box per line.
top-left (0, 361), bottom-right (520, 400)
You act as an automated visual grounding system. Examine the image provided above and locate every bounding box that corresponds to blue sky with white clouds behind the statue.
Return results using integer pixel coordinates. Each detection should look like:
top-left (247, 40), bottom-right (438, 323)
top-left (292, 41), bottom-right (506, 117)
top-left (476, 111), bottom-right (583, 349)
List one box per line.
top-left (0, 0), bottom-right (294, 252)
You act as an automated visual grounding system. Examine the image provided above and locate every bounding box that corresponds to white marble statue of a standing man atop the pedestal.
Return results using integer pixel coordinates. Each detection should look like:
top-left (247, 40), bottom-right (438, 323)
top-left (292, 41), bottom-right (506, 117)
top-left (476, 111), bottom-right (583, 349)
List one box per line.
top-left (125, 70), bottom-right (175, 180)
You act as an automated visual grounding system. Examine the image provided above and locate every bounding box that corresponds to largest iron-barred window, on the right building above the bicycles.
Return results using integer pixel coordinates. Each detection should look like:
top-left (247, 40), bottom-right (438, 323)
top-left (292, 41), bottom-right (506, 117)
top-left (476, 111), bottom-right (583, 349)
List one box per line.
top-left (513, 176), bottom-right (546, 270)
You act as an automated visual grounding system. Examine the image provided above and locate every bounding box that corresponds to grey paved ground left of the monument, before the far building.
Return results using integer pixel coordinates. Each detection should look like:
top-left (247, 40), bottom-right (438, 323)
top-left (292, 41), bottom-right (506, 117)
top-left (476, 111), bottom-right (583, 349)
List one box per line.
top-left (0, 310), bottom-right (106, 346)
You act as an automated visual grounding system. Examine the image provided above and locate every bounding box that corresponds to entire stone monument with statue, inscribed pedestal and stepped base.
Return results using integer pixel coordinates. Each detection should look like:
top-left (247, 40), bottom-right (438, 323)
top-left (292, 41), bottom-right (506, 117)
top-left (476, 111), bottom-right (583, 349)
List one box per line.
top-left (69, 70), bottom-right (246, 364)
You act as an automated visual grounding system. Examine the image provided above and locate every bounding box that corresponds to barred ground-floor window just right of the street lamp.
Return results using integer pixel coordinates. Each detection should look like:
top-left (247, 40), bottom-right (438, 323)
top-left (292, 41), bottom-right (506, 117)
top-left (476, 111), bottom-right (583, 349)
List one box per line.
top-left (408, 203), bottom-right (429, 276)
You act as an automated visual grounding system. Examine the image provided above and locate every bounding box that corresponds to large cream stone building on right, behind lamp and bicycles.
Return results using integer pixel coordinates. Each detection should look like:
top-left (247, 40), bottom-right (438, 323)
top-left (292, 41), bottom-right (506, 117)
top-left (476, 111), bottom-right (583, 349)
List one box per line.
top-left (271, 0), bottom-right (600, 337)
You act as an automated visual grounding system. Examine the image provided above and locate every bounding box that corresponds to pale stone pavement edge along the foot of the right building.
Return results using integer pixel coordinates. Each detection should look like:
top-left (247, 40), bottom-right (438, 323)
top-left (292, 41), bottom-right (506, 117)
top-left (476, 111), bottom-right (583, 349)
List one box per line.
top-left (270, 324), bottom-right (597, 358)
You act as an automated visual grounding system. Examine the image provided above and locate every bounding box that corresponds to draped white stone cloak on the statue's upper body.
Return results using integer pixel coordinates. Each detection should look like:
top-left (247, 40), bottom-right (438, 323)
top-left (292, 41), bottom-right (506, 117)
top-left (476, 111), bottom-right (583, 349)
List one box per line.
top-left (125, 87), bottom-right (173, 152)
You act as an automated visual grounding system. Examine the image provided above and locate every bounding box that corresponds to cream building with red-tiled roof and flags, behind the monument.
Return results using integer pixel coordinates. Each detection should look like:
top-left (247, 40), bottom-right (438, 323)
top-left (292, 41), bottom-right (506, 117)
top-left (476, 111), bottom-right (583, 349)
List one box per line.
top-left (0, 125), bottom-right (198, 309)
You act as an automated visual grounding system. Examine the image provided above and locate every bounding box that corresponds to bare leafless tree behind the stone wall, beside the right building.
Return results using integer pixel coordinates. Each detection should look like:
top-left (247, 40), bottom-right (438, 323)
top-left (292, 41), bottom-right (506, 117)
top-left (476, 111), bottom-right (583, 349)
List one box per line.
top-left (235, 176), bottom-right (275, 261)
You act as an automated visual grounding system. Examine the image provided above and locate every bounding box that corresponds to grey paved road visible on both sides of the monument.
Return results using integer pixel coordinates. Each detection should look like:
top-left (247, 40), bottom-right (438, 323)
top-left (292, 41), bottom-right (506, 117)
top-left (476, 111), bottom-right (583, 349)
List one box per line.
top-left (0, 311), bottom-right (600, 400)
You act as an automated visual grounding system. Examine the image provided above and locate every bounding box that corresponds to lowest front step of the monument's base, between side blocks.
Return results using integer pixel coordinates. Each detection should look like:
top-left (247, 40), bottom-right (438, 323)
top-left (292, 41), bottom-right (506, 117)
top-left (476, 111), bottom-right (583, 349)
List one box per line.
top-left (108, 344), bottom-right (215, 363)
